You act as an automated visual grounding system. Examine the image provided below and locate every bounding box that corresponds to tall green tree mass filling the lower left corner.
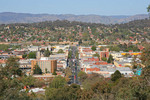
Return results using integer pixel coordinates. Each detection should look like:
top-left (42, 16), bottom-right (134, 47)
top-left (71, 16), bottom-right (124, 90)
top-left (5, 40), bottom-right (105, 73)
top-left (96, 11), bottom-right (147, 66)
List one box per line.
top-left (0, 57), bottom-right (30, 100)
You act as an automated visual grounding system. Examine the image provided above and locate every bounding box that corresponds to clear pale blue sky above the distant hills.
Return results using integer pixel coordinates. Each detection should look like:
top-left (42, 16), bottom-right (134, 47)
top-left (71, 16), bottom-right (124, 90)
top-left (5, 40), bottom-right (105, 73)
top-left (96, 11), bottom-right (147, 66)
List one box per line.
top-left (0, 0), bottom-right (150, 16)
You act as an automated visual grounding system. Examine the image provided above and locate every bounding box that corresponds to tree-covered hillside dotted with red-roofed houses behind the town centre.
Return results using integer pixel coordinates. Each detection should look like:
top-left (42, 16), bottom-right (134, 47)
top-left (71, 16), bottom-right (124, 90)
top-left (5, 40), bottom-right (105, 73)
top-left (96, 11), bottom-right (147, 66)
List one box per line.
top-left (0, 19), bottom-right (150, 43)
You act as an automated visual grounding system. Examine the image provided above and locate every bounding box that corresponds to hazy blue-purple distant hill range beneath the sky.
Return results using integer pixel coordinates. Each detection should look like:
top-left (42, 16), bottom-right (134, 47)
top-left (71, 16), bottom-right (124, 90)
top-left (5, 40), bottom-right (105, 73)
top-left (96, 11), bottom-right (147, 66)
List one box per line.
top-left (0, 12), bottom-right (148, 24)
